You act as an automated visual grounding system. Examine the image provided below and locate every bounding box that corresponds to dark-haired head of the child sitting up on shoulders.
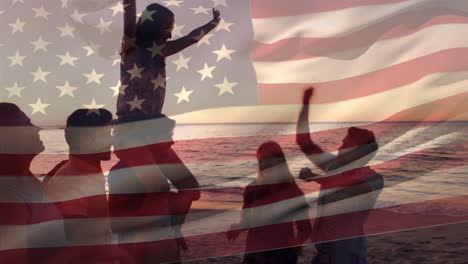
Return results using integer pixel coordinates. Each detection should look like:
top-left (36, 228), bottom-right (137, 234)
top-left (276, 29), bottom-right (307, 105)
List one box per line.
top-left (136, 3), bottom-right (174, 46)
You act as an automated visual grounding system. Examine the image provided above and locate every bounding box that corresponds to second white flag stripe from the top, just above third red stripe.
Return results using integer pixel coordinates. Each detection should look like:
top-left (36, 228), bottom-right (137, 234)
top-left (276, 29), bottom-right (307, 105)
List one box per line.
top-left (254, 24), bottom-right (468, 83)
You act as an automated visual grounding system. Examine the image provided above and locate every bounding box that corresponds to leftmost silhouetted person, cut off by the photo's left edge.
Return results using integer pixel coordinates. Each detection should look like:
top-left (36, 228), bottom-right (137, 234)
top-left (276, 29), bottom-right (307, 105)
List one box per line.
top-left (0, 103), bottom-right (67, 263)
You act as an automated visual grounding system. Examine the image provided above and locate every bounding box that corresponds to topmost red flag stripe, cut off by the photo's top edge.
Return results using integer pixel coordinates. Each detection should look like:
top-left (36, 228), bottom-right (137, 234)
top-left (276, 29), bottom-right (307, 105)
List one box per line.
top-left (251, 0), bottom-right (406, 18)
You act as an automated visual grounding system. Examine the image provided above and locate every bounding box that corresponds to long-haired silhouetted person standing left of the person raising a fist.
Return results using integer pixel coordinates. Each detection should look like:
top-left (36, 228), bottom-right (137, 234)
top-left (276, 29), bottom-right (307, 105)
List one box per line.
top-left (227, 141), bottom-right (312, 263)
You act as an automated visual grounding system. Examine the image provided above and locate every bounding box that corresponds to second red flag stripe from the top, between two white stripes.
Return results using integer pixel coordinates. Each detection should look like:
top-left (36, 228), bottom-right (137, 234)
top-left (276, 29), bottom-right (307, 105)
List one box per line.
top-left (252, 16), bottom-right (468, 62)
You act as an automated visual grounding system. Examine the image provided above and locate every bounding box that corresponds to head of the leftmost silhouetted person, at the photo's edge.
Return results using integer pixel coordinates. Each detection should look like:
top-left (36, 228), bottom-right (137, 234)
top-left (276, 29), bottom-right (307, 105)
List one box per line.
top-left (0, 103), bottom-right (44, 172)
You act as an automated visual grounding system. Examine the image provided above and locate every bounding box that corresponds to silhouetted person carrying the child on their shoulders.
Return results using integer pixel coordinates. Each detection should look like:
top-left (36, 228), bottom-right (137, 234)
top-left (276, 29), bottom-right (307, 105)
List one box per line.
top-left (109, 116), bottom-right (200, 263)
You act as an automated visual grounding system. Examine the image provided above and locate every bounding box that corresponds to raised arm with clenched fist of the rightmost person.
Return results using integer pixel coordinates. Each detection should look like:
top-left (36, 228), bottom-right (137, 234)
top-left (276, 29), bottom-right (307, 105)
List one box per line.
top-left (296, 87), bottom-right (336, 171)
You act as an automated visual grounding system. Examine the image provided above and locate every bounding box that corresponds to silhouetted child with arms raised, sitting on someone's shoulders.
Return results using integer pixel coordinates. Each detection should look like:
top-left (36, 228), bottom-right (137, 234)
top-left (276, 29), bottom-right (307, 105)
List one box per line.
top-left (117, 0), bottom-right (220, 117)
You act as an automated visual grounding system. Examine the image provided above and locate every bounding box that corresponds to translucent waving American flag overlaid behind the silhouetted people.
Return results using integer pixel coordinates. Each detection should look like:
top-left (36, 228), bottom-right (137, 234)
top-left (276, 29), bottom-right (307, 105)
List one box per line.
top-left (0, 0), bottom-right (468, 263)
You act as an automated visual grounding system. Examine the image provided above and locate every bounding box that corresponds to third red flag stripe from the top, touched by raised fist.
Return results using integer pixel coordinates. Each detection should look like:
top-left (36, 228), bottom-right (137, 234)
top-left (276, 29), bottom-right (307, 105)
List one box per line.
top-left (258, 48), bottom-right (468, 105)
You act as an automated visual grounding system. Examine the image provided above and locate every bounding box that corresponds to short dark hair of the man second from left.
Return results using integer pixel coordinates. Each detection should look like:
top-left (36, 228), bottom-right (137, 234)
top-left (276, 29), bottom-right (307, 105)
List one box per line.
top-left (65, 108), bottom-right (112, 149)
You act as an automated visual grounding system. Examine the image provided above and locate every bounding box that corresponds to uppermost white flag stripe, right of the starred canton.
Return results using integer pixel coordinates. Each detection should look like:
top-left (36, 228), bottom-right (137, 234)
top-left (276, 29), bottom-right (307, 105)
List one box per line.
top-left (252, 0), bottom-right (468, 44)
